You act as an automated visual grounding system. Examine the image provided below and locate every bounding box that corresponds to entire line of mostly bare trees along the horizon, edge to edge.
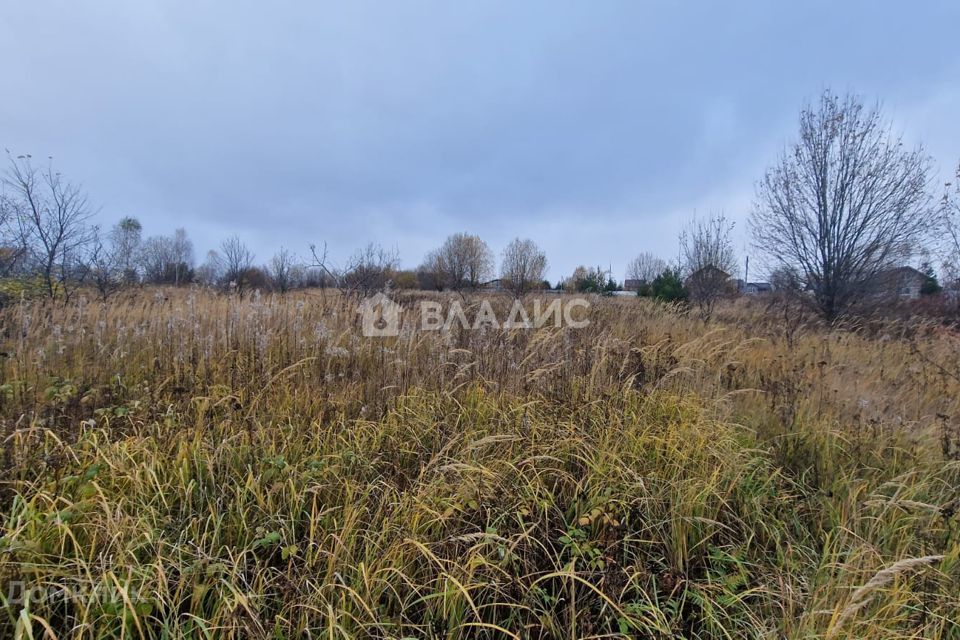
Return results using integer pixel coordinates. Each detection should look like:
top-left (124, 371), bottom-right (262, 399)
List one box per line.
top-left (0, 90), bottom-right (960, 320)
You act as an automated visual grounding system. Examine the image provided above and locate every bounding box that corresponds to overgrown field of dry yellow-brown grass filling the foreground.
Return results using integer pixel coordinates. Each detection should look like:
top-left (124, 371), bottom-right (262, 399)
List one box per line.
top-left (0, 289), bottom-right (960, 639)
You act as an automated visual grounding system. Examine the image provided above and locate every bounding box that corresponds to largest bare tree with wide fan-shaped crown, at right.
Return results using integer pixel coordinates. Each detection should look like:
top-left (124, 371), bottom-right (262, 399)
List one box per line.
top-left (752, 91), bottom-right (936, 320)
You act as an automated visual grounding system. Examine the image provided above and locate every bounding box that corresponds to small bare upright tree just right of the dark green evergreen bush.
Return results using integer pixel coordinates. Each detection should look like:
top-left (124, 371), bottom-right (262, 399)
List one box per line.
top-left (680, 214), bottom-right (737, 318)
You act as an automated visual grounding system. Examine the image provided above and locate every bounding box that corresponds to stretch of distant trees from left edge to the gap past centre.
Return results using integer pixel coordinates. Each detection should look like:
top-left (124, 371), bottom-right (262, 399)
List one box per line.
top-left (0, 165), bottom-right (548, 299)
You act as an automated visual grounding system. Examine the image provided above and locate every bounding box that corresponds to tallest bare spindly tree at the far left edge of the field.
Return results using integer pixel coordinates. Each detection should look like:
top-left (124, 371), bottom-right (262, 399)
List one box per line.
top-left (3, 155), bottom-right (93, 298)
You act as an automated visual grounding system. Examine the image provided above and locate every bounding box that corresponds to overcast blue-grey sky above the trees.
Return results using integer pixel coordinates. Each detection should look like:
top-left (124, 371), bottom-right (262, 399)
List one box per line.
top-left (0, 0), bottom-right (960, 279)
